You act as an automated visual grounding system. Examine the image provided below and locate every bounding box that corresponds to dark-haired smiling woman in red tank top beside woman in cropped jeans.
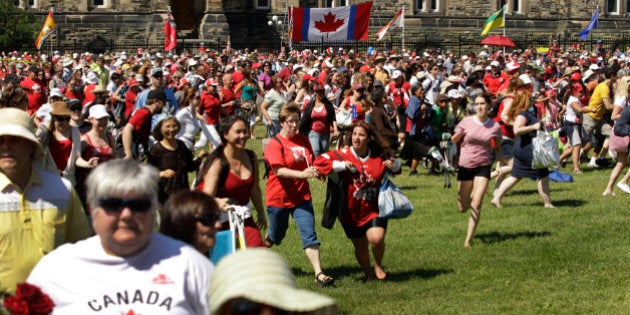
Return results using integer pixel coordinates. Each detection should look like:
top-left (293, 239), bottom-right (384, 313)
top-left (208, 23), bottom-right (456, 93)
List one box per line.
top-left (197, 115), bottom-right (267, 247)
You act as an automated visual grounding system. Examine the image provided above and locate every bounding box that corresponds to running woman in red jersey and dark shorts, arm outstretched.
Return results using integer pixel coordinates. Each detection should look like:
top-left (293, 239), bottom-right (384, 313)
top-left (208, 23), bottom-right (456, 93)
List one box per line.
top-left (313, 121), bottom-right (400, 280)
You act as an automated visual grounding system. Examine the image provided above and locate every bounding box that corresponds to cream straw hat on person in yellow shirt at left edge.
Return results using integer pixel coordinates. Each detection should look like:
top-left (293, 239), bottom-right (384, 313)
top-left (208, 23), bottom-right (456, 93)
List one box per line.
top-left (0, 107), bottom-right (44, 160)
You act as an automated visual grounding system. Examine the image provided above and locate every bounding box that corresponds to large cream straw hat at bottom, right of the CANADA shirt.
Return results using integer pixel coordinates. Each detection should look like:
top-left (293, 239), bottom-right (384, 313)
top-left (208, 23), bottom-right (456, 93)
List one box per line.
top-left (210, 248), bottom-right (338, 314)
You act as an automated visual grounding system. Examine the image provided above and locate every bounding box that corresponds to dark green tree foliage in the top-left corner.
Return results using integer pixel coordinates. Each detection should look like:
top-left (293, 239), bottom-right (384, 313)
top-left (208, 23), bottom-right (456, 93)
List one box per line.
top-left (0, 1), bottom-right (39, 50)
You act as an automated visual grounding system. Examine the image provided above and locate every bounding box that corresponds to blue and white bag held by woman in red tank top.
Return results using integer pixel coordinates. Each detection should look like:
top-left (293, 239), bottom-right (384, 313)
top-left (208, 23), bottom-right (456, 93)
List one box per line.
top-left (210, 209), bottom-right (247, 265)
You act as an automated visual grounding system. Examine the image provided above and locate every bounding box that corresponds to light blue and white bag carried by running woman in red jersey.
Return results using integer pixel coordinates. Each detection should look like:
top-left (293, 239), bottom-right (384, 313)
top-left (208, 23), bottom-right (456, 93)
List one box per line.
top-left (378, 175), bottom-right (413, 219)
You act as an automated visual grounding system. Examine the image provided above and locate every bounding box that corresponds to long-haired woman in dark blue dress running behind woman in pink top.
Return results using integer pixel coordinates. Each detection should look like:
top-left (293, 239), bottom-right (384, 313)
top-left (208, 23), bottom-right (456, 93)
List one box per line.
top-left (491, 79), bottom-right (554, 208)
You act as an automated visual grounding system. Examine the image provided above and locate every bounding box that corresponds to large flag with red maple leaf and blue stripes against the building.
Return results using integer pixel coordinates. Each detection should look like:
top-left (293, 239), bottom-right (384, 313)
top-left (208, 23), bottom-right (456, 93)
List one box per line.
top-left (289, 1), bottom-right (372, 42)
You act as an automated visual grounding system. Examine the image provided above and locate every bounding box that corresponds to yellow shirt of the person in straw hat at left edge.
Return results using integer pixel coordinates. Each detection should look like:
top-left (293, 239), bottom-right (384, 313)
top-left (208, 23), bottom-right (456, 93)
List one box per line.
top-left (0, 169), bottom-right (92, 294)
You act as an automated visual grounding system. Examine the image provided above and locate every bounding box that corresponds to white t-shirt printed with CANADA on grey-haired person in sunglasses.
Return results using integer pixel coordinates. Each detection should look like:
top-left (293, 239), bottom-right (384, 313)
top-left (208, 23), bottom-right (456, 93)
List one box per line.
top-left (27, 232), bottom-right (214, 315)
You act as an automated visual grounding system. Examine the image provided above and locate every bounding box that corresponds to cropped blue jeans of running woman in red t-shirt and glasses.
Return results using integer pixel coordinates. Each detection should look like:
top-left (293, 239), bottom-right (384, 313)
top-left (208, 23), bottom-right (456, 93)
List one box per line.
top-left (267, 200), bottom-right (319, 248)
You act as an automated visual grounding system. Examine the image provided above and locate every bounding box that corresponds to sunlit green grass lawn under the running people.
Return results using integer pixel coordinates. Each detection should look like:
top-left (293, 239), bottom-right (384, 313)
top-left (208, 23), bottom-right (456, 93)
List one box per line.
top-left (238, 126), bottom-right (630, 314)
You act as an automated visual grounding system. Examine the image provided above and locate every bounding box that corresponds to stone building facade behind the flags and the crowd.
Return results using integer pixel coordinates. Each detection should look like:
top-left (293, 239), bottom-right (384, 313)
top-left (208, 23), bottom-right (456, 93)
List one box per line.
top-left (20, 0), bottom-right (630, 48)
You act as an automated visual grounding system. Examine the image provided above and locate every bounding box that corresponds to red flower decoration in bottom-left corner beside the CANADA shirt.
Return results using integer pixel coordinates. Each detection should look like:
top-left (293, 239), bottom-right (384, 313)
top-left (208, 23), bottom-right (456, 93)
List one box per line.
top-left (3, 283), bottom-right (55, 315)
